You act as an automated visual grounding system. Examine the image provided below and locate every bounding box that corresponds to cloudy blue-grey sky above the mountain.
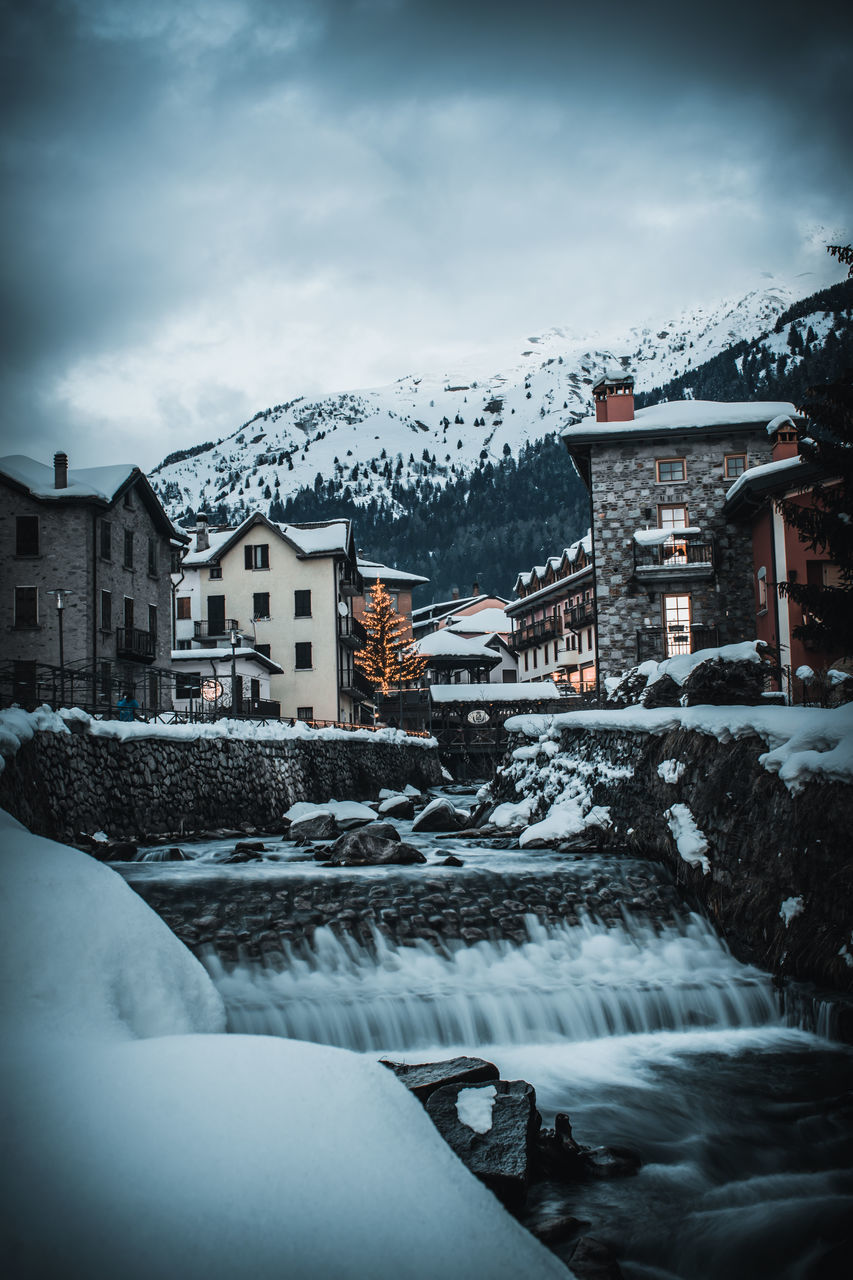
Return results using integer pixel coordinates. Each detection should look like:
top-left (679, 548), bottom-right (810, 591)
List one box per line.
top-left (0, 0), bottom-right (853, 467)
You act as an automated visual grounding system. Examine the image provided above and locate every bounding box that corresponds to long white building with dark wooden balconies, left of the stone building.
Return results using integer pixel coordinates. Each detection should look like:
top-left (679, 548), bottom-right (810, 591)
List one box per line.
top-left (506, 534), bottom-right (596, 694)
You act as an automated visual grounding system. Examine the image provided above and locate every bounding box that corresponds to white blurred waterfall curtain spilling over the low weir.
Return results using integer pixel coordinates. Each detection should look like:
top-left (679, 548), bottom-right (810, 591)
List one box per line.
top-left (205, 915), bottom-right (780, 1052)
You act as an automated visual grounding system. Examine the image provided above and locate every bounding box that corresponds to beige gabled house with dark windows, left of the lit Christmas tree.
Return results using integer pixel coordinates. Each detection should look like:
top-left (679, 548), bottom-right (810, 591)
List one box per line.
top-left (175, 515), bottom-right (370, 723)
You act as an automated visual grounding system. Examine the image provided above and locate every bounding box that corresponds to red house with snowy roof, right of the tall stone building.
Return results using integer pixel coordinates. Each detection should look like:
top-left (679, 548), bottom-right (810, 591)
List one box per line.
top-left (725, 415), bottom-right (843, 701)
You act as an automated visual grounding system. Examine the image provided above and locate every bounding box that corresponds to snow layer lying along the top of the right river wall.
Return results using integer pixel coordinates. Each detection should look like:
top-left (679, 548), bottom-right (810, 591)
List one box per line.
top-left (506, 703), bottom-right (853, 795)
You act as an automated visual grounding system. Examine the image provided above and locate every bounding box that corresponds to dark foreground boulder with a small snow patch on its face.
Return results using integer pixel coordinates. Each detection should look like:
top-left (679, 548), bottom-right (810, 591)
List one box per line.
top-left (427, 1080), bottom-right (540, 1210)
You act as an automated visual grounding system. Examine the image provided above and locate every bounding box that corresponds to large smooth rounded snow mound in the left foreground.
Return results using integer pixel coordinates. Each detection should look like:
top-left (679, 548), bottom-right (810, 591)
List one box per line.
top-left (0, 817), bottom-right (566, 1280)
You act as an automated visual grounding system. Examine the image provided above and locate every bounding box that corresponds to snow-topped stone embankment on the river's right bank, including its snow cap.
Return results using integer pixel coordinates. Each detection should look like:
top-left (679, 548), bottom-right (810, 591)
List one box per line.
top-left (492, 704), bottom-right (853, 1008)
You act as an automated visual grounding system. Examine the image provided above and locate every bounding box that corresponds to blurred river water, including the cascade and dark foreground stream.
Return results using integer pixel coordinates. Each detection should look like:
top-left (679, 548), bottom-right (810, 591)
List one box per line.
top-left (137, 783), bottom-right (853, 1280)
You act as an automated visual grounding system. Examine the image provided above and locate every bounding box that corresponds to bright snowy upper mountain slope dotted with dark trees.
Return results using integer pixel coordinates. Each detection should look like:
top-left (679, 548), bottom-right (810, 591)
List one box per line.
top-left (151, 284), bottom-right (809, 524)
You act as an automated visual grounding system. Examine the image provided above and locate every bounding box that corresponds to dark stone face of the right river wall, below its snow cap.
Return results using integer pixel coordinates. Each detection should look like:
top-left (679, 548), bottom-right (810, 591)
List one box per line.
top-left (493, 728), bottom-right (853, 992)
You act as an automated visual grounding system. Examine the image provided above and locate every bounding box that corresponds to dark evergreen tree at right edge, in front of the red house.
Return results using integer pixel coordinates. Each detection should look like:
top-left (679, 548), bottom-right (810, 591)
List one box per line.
top-left (777, 371), bottom-right (853, 655)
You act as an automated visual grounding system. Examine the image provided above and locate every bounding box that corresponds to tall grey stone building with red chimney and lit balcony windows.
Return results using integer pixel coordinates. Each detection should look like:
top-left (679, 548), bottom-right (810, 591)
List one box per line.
top-left (562, 369), bottom-right (795, 678)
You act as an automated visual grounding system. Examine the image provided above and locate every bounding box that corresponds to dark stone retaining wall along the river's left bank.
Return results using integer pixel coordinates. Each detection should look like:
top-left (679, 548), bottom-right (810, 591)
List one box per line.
top-left (0, 722), bottom-right (441, 842)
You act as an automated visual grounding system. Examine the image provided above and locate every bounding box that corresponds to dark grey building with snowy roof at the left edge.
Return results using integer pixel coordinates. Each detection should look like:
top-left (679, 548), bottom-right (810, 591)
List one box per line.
top-left (0, 453), bottom-right (187, 710)
